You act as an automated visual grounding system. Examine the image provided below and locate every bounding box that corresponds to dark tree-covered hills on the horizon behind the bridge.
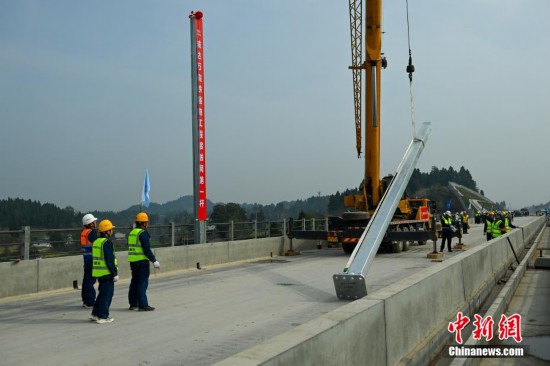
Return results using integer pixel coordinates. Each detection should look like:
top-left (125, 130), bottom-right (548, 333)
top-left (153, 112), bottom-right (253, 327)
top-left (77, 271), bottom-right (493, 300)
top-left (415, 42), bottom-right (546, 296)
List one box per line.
top-left (0, 167), bottom-right (520, 230)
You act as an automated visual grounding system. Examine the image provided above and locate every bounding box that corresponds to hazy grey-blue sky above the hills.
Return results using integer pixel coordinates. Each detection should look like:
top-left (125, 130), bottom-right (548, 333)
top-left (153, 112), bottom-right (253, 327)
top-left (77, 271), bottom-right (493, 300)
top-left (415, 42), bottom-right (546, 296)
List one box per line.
top-left (0, 0), bottom-right (550, 212)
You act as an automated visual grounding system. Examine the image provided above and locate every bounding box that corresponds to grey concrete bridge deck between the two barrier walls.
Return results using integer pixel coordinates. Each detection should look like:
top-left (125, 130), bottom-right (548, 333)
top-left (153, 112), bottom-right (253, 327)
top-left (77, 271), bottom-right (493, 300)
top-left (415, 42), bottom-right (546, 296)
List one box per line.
top-left (0, 217), bottom-right (544, 365)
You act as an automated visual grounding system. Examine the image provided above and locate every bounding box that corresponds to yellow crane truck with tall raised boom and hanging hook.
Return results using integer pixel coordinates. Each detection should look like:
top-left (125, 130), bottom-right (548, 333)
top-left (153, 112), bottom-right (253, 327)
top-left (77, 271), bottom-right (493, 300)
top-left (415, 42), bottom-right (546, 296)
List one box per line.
top-left (289, 0), bottom-right (436, 253)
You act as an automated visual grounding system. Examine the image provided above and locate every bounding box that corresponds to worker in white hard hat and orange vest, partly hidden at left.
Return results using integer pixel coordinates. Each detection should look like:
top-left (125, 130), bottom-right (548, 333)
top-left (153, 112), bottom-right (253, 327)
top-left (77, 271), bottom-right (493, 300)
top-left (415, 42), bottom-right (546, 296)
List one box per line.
top-left (80, 214), bottom-right (97, 309)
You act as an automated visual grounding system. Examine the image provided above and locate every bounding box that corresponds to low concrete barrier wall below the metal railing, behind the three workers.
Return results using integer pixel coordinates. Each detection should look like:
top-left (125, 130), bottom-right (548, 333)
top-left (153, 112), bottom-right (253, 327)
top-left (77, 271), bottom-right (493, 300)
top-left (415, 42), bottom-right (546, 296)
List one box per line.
top-left (0, 237), bottom-right (317, 298)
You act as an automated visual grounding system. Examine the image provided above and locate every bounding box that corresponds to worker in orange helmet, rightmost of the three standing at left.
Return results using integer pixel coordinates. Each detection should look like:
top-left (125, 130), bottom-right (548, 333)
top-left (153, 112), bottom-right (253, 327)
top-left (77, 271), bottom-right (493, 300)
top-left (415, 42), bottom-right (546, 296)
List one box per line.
top-left (128, 212), bottom-right (160, 311)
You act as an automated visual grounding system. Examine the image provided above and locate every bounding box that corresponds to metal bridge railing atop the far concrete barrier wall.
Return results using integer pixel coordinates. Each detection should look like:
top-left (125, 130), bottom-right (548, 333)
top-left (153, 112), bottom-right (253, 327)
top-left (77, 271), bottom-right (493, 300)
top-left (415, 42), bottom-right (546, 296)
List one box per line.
top-left (0, 219), bottom-right (327, 262)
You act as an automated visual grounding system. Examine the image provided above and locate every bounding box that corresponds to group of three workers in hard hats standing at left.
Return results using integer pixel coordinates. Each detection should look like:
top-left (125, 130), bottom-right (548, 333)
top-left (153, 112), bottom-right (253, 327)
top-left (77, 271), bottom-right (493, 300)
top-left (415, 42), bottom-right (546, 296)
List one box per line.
top-left (80, 212), bottom-right (160, 324)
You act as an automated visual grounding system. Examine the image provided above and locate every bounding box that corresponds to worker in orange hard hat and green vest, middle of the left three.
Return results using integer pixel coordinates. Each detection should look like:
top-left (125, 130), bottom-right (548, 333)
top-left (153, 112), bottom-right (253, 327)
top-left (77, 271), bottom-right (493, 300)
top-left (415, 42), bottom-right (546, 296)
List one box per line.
top-left (90, 220), bottom-right (118, 324)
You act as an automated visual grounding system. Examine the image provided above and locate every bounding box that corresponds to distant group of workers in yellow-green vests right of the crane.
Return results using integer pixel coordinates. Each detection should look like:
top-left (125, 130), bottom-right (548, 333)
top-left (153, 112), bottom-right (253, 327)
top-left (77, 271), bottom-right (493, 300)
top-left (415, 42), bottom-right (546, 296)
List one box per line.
top-left (439, 211), bottom-right (516, 252)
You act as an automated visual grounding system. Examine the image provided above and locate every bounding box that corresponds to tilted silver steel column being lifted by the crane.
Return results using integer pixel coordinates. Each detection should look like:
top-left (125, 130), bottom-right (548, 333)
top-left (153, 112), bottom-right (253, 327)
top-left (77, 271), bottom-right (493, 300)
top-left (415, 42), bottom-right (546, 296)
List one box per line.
top-left (332, 122), bottom-right (431, 300)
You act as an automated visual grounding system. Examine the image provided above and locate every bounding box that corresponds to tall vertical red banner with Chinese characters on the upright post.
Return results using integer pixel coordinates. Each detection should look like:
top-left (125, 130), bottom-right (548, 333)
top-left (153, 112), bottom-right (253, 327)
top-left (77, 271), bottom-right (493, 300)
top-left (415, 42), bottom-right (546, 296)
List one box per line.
top-left (194, 11), bottom-right (207, 220)
